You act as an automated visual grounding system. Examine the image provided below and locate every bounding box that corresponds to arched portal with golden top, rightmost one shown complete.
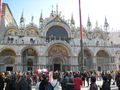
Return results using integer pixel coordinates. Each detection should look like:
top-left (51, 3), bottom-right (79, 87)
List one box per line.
top-left (96, 50), bottom-right (109, 71)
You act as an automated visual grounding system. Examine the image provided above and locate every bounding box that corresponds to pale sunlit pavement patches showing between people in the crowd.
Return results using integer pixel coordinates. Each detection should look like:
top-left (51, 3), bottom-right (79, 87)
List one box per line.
top-left (32, 81), bottom-right (118, 90)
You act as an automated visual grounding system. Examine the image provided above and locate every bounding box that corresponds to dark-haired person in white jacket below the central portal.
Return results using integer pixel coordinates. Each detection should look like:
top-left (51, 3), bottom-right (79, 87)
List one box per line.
top-left (51, 73), bottom-right (62, 90)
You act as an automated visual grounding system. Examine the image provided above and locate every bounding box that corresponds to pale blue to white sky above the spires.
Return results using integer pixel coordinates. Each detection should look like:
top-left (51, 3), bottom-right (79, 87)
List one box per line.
top-left (3, 0), bottom-right (120, 31)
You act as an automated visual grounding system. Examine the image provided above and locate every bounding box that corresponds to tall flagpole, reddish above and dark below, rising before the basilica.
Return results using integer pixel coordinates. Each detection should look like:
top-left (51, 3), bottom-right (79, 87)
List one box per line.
top-left (78, 0), bottom-right (84, 72)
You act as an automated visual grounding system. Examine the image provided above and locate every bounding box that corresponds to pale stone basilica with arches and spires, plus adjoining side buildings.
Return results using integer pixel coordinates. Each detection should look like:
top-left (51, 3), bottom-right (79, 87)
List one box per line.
top-left (0, 4), bottom-right (120, 71)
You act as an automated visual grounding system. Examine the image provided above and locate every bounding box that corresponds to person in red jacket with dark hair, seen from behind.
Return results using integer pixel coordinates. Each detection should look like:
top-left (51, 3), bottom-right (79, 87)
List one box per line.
top-left (73, 74), bottom-right (82, 90)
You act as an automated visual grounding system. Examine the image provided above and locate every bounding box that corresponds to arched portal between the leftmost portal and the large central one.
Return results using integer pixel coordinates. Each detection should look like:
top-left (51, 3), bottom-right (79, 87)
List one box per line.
top-left (22, 48), bottom-right (38, 71)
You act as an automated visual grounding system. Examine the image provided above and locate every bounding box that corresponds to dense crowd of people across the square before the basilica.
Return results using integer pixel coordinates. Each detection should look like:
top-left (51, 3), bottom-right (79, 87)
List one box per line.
top-left (0, 71), bottom-right (120, 90)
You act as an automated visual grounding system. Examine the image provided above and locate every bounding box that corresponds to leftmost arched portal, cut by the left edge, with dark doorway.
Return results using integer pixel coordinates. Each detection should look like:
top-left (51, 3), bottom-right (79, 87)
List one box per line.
top-left (0, 49), bottom-right (16, 71)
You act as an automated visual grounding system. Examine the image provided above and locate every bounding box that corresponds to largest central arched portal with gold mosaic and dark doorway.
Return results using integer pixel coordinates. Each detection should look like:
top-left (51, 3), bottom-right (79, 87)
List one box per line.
top-left (48, 44), bottom-right (70, 71)
